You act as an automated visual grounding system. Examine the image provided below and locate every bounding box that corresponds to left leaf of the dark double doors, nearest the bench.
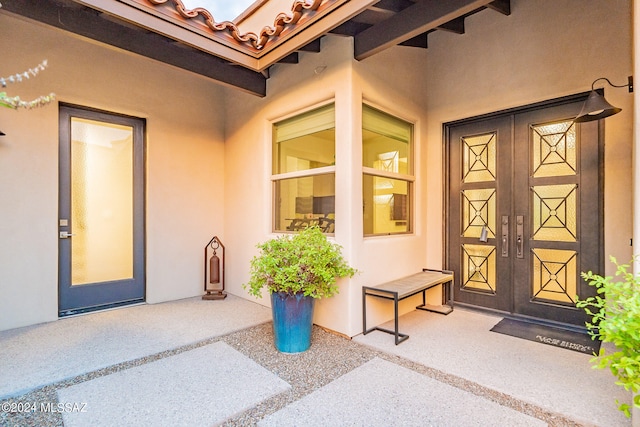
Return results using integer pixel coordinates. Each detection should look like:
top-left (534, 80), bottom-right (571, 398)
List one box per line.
top-left (448, 115), bottom-right (512, 311)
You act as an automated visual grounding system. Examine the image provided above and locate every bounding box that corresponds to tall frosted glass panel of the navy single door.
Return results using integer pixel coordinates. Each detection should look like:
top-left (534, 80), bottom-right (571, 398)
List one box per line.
top-left (71, 117), bottom-right (133, 285)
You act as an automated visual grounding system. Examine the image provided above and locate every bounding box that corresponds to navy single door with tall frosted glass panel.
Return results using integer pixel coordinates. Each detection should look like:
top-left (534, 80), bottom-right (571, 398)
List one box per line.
top-left (58, 106), bottom-right (145, 316)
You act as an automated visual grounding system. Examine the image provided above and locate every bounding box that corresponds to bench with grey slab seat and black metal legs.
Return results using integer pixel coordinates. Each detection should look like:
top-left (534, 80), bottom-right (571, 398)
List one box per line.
top-left (362, 268), bottom-right (453, 345)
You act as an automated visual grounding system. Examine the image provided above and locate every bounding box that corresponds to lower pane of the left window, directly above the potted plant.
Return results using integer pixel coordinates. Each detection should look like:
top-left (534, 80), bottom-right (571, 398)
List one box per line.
top-left (274, 174), bottom-right (336, 233)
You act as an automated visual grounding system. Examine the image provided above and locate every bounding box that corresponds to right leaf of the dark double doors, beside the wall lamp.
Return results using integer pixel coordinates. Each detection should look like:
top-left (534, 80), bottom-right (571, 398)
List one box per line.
top-left (513, 102), bottom-right (602, 325)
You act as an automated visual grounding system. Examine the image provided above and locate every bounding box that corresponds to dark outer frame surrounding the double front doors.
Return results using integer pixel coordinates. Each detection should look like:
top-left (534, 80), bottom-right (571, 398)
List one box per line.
top-left (442, 89), bottom-right (605, 326)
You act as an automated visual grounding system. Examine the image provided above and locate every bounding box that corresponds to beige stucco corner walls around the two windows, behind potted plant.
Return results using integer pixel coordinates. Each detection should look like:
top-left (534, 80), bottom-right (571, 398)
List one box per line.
top-left (225, 36), bottom-right (425, 336)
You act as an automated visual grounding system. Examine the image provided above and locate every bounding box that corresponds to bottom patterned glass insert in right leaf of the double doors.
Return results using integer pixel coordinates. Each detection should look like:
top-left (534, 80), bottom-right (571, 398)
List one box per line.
top-left (532, 248), bottom-right (578, 305)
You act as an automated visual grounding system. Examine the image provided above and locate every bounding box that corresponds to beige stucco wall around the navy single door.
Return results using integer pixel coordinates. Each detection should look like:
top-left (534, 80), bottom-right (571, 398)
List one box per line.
top-left (0, 11), bottom-right (225, 330)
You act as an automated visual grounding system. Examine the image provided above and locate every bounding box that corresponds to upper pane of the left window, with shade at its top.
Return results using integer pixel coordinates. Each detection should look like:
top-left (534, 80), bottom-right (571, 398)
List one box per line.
top-left (273, 104), bottom-right (336, 174)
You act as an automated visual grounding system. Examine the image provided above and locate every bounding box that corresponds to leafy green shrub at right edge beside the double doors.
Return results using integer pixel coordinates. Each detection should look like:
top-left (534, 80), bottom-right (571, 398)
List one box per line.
top-left (577, 257), bottom-right (640, 426)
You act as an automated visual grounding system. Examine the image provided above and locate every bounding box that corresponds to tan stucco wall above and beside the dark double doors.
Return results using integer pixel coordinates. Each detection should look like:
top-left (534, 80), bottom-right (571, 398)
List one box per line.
top-left (425, 0), bottom-right (633, 271)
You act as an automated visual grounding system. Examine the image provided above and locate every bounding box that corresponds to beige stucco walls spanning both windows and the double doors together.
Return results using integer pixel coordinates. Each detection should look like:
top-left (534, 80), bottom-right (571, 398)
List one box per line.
top-left (226, 0), bottom-right (633, 335)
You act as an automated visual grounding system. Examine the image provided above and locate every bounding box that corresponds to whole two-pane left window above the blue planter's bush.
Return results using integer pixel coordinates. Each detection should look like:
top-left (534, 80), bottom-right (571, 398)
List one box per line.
top-left (271, 104), bottom-right (336, 233)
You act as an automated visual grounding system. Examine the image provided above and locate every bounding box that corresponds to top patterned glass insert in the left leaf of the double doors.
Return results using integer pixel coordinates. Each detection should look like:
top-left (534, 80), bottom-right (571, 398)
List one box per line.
top-left (462, 132), bottom-right (497, 184)
